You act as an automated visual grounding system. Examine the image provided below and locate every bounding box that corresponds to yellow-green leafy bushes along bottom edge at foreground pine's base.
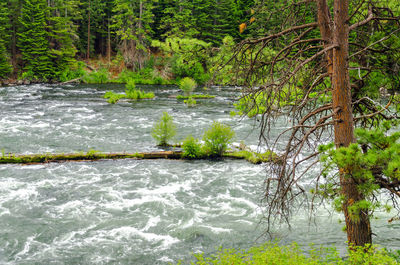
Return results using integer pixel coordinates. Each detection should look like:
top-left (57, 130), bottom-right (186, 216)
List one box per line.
top-left (191, 243), bottom-right (398, 265)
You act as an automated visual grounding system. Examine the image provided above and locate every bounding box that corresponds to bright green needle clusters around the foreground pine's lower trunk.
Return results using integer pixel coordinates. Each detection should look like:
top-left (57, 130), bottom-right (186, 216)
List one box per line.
top-left (314, 122), bottom-right (400, 220)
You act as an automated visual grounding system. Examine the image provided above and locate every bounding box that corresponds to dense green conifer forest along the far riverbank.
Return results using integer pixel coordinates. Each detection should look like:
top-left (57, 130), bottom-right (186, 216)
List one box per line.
top-left (0, 0), bottom-right (257, 83)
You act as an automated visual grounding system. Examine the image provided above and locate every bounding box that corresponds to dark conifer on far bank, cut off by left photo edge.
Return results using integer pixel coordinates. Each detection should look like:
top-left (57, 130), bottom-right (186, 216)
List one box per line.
top-left (0, 2), bottom-right (11, 78)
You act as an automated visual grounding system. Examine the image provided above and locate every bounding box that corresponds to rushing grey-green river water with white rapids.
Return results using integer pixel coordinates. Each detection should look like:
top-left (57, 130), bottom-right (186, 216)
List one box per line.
top-left (0, 85), bottom-right (400, 264)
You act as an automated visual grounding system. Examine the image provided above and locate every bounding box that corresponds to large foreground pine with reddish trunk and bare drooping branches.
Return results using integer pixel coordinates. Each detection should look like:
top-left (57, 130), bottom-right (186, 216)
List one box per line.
top-left (234, 0), bottom-right (400, 246)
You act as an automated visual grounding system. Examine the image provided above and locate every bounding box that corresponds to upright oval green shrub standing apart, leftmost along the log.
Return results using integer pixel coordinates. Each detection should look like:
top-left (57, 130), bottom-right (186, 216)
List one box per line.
top-left (151, 112), bottom-right (176, 146)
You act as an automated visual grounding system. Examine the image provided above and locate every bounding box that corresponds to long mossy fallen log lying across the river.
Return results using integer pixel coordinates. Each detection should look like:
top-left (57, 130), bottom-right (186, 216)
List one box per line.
top-left (0, 151), bottom-right (279, 164)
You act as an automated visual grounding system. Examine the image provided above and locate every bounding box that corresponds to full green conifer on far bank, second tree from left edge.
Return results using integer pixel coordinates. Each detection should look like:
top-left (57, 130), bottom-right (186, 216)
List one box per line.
top-left (18, 0), bottom-right (55, 81)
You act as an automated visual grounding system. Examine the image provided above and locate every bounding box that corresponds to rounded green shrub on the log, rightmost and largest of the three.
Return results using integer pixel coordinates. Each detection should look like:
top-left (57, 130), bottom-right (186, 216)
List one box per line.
top-left (203, 122), bottom-right (235, 157)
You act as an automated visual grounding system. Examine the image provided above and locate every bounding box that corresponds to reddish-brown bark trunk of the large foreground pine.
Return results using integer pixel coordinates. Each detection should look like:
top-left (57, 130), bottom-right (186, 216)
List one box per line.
top-left (332, 0), bottom-right (372, 246)
